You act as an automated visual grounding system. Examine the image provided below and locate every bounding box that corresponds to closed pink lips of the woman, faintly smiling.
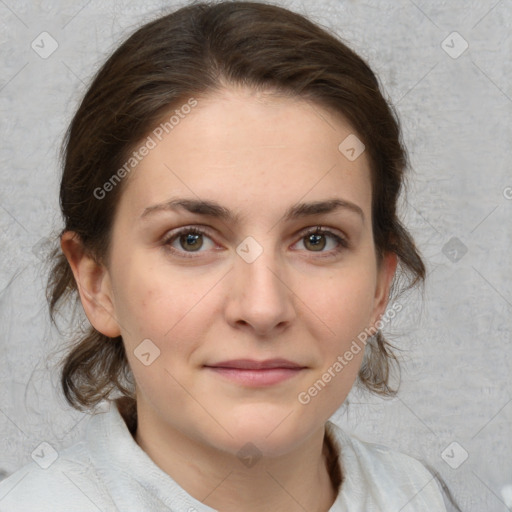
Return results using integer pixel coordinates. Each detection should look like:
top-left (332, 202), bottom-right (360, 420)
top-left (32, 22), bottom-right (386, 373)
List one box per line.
top-left (204, 359), bottom-right (307, 387)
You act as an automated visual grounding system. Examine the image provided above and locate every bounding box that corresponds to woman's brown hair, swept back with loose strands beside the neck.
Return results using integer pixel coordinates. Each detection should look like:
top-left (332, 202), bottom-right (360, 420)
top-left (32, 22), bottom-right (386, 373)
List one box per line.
top-left (47, 1), bottom-right (425, 409)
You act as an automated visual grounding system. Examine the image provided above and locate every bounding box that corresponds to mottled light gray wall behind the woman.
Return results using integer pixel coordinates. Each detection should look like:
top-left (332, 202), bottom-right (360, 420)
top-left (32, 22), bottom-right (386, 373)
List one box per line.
top-left (0, 0), bottom-right (512, 512)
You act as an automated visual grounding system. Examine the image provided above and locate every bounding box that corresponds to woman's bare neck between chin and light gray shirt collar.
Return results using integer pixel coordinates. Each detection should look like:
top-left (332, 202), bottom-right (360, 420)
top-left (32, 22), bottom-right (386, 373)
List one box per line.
top-left (130, 402), bottom-right (339, 512)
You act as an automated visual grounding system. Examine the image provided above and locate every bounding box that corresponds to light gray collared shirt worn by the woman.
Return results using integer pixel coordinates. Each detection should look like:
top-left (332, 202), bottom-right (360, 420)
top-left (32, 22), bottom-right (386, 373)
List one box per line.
top-left (0, 403), bottom-right (446, 512)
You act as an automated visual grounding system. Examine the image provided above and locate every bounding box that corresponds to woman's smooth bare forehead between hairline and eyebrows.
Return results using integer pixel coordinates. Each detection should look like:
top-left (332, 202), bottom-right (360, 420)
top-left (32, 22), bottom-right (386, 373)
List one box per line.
top-left (116, 88), bottom-right (371, 223)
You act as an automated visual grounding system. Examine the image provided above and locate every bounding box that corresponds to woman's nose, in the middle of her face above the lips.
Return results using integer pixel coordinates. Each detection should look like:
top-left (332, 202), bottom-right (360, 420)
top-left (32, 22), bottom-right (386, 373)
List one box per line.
top-left (225, 239), bottom-right (296, 336)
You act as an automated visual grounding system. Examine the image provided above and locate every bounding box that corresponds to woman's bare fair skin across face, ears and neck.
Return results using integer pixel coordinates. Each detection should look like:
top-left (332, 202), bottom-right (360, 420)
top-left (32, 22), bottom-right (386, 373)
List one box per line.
top-left (61, 87), bottom-right (397, 512)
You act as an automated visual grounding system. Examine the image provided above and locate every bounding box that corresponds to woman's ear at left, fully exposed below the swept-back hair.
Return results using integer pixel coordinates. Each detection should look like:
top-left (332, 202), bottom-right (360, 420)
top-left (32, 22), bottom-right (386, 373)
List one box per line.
top-left (60, 231), bottom-right (121, 338)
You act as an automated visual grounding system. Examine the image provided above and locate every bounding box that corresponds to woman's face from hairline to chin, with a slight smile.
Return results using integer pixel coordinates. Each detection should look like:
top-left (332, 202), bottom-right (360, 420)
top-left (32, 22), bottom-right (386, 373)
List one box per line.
top-left (77, 88), bottom-right (395, 455)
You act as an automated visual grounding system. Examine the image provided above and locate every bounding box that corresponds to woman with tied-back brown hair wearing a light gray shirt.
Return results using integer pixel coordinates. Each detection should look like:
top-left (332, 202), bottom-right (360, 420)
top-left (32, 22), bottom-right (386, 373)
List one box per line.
top-left (0, 2), bottom-right (456, 512)
